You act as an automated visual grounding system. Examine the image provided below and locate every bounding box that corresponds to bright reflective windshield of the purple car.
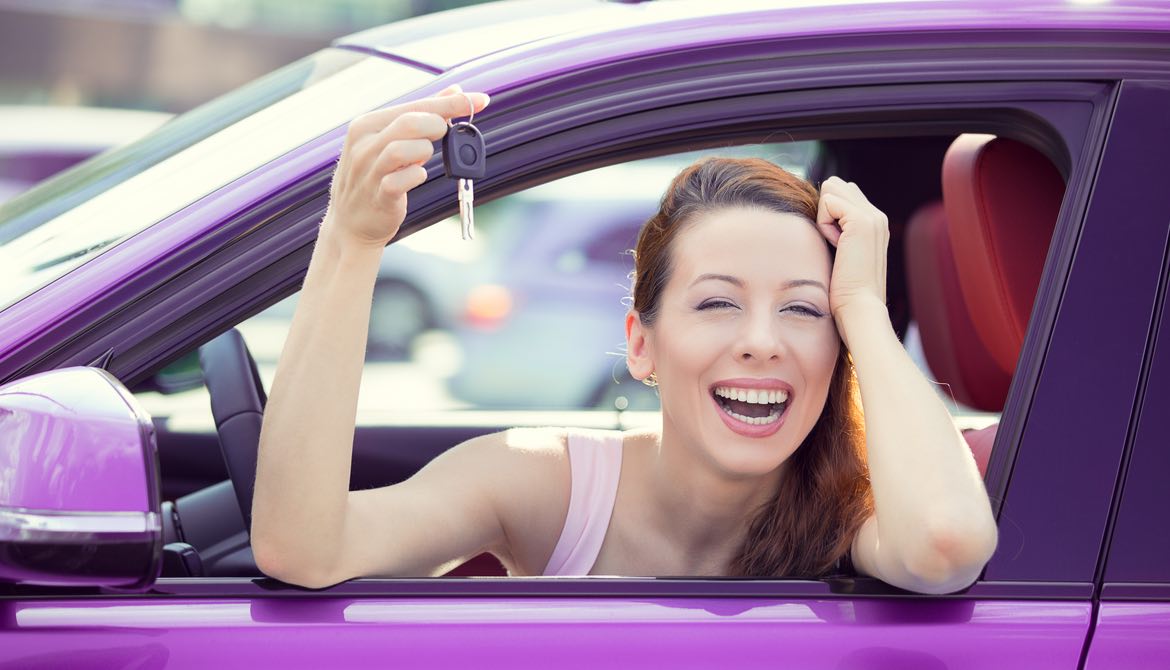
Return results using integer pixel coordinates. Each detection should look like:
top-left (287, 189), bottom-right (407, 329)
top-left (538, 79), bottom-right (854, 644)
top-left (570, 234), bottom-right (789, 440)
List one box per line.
top-left (0, 49), bottom-right (433, 309)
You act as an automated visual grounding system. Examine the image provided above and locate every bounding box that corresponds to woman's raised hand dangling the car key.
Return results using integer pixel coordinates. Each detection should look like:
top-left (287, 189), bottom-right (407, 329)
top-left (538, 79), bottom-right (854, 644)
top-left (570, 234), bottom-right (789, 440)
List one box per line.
top-left (322, 85), bottom-right (488, 248)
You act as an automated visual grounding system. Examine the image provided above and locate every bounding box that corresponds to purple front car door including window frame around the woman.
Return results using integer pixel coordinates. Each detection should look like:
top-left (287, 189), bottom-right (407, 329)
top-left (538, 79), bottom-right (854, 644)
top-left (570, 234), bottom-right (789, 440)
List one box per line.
top-left (2, 26), bottom-right (1164, 668)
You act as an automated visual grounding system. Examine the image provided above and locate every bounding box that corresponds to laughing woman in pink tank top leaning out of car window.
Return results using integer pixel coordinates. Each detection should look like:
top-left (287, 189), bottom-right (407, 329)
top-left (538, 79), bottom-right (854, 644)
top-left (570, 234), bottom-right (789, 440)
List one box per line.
top-left (252, 87), bottom-right (996, 593)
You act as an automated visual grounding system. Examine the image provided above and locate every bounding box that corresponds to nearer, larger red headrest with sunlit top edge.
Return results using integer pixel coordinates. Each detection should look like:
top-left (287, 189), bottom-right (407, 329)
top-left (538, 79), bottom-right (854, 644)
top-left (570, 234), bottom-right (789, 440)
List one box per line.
top-left (943, 134), bottom-right (1065, 372)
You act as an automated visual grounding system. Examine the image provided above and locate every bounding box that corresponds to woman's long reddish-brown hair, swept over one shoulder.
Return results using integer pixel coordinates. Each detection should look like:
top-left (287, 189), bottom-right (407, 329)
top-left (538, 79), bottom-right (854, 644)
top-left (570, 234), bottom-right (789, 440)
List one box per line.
top-left (633, 158), bottom-right (873, 578)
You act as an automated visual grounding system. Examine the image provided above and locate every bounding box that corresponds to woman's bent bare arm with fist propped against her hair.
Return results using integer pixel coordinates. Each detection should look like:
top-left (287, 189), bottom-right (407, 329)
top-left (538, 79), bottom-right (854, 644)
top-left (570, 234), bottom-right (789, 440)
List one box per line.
top-left (818, 178), bottom-right (997, 593)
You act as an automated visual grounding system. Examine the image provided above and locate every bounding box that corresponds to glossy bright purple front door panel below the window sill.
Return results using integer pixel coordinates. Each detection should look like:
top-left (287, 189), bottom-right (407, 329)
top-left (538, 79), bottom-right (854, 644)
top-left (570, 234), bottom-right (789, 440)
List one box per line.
top-left (0, 598), bottom-right (1089, 670)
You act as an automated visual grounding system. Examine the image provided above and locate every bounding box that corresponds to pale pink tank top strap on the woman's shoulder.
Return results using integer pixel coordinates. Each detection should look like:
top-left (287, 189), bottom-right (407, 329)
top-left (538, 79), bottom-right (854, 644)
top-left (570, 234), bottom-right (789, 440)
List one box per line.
top-left (544, 430), bottom-right (621, 576)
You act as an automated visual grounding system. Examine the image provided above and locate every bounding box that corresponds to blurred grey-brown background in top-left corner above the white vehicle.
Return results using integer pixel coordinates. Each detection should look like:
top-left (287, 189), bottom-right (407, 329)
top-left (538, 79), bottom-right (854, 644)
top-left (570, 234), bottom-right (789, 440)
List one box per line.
top-left (0, 0), bottom-right (493, 113)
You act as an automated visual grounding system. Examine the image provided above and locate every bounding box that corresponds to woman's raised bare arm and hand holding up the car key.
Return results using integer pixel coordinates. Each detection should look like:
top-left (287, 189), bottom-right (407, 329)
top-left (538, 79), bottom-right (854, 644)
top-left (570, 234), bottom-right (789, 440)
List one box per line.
top-left (252, 89), bottom-right (490, 586)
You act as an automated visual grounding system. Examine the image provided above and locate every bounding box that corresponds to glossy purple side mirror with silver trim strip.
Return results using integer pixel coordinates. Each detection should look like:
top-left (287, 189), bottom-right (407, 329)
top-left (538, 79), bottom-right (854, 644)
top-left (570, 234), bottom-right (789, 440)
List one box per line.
top-left (0, 367), bottom-right (163, 590)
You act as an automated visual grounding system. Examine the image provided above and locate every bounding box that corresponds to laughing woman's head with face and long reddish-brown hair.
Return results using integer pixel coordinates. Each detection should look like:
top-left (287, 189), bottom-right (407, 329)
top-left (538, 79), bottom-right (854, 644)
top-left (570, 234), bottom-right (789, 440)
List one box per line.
top-left (627, 159), bottom-right (873, 576)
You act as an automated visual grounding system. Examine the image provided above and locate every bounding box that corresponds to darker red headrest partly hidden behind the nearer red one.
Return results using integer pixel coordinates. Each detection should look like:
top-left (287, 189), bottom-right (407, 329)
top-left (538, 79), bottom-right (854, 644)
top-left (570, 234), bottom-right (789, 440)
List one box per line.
top-left (906, 202), bottom-right (1012, 412)
